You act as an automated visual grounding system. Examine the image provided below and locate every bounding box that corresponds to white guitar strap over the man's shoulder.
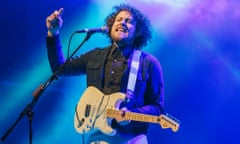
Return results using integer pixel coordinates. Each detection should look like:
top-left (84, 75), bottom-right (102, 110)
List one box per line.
top-left (127, 50), bottom-right (142, 99)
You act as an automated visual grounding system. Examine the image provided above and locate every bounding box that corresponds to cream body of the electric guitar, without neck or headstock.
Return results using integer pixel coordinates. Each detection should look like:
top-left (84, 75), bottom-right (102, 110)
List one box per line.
top-left (74, 87), bottom-right (125, 135)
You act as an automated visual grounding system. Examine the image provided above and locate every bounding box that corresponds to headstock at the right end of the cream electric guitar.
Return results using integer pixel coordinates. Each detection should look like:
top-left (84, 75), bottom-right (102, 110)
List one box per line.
top-left (158, 114), bottom-right (180, 132)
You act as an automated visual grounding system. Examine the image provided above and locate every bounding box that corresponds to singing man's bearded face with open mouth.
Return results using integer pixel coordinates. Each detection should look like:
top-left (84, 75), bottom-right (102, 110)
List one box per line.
top-left (111, 11), bottom-right (136, 46)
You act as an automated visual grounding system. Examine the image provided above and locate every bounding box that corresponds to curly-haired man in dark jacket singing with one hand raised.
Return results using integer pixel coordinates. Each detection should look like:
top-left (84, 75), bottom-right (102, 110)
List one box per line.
top-left (46, 4), bottom-right (164, 144)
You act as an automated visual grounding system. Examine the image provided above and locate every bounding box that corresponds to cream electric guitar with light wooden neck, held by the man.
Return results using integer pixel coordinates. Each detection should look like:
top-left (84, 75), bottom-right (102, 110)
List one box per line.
top-left (74, 87), bottom-right (180, 136)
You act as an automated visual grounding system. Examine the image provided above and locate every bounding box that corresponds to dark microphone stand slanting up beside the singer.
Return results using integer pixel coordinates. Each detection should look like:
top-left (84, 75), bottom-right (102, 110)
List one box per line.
top-left (1, 32), bottom-right (93, 144)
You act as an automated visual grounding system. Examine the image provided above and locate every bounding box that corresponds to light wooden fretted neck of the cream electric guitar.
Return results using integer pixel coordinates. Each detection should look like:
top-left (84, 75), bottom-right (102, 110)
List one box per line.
top-left (107, 109), bottom-right (160, 123)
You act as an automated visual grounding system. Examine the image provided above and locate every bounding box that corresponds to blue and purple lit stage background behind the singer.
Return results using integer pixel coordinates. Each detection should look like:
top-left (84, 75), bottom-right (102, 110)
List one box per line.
top-left (0, 0), bottom-right (240, 144)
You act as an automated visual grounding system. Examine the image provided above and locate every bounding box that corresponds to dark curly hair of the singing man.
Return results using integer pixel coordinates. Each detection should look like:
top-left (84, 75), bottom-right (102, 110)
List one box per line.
top-left (105, 4), bottom-right (152, 49)
